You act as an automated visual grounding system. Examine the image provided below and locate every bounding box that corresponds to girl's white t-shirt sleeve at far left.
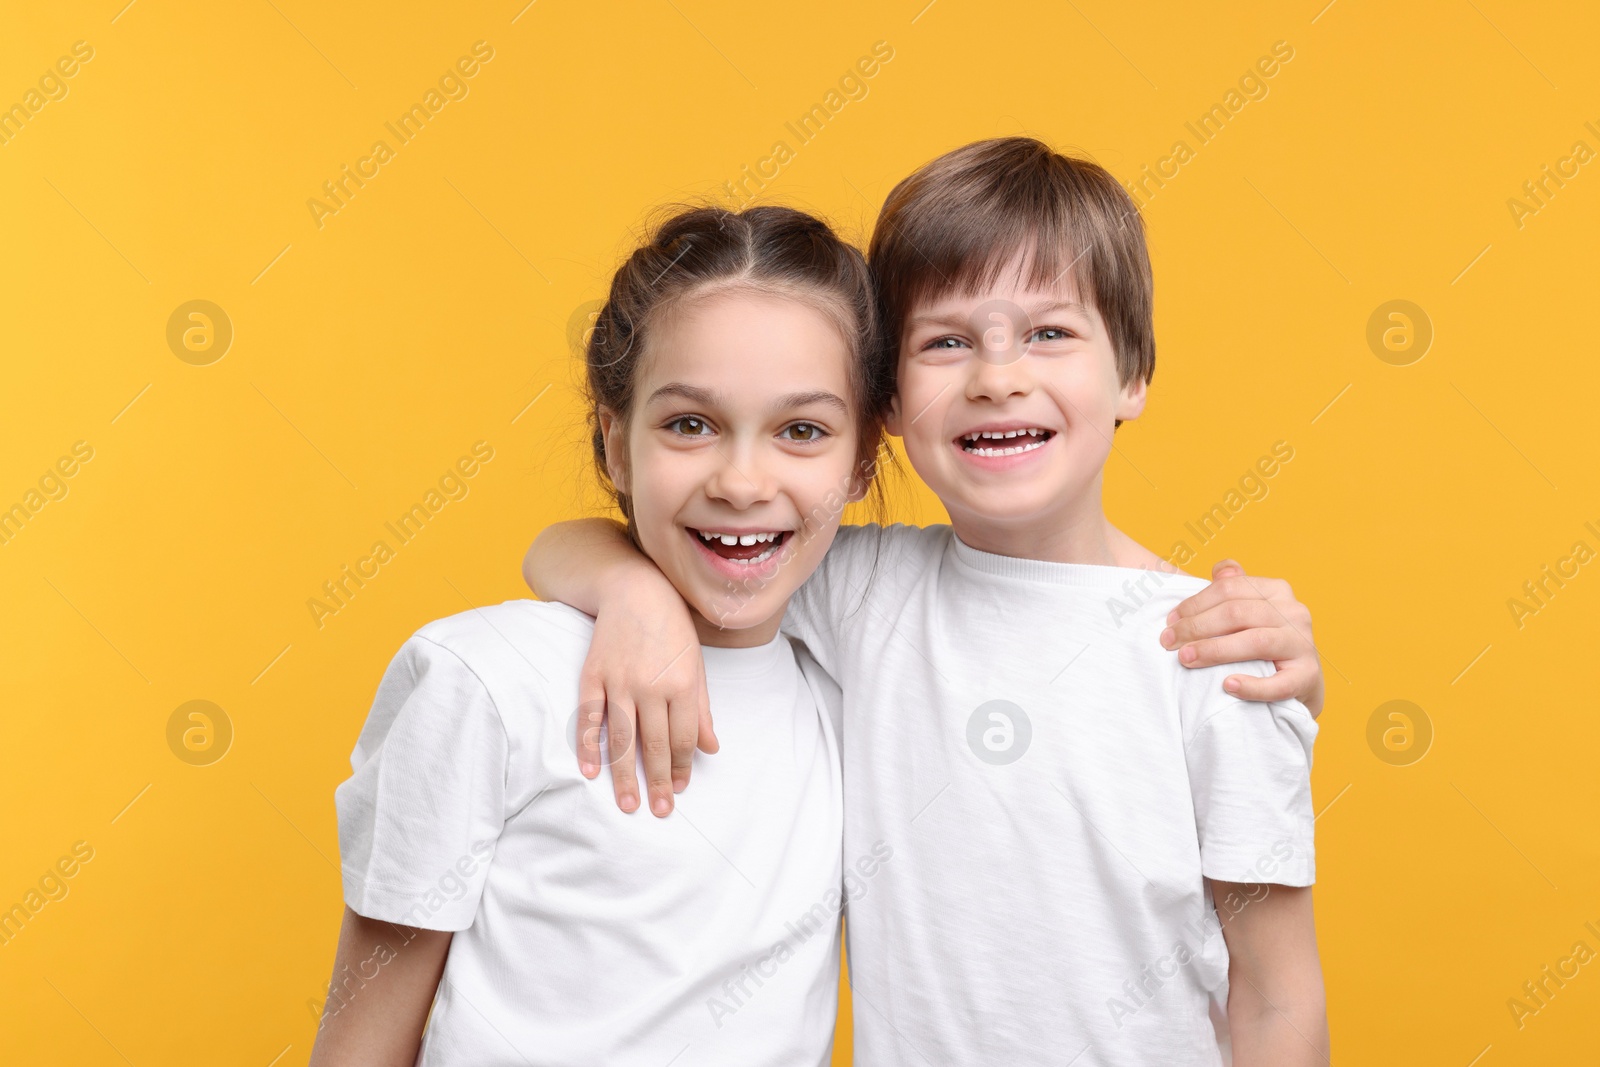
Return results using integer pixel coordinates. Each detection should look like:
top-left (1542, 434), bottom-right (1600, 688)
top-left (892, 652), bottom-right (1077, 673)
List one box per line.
top-left (334, 637), bottom-right (509, 929)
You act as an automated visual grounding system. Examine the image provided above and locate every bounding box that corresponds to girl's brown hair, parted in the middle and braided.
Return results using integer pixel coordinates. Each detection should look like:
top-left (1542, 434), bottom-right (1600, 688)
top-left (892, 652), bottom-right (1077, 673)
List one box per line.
top-left (584, 206), bottom-right (893, 525)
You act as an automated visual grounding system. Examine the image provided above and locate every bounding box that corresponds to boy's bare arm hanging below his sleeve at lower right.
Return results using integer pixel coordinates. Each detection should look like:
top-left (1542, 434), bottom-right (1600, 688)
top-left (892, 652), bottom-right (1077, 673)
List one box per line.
top-left (1210, 881), bottom-right (1331, 1067)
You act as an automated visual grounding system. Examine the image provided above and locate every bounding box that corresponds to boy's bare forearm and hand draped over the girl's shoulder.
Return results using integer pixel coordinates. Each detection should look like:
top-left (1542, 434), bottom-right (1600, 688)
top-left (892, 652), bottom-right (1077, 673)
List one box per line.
top-left (522, 518), bottom-right (717, 816)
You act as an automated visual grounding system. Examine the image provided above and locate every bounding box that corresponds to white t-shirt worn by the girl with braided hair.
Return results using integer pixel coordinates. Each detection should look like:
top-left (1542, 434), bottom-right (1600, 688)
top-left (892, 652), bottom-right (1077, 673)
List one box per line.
top-left (330, 600), bottom-right (842, 1067)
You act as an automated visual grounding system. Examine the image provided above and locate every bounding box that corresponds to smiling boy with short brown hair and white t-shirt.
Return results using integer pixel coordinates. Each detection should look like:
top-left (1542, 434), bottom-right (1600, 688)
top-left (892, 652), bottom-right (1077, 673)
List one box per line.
top-left (528, 138), bottom-right (1328, 1067)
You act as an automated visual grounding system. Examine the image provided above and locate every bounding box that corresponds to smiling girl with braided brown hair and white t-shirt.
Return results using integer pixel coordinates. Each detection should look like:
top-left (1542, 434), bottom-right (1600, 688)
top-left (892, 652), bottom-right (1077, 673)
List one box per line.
top-left (312, 206), bottom-right (886, 1067)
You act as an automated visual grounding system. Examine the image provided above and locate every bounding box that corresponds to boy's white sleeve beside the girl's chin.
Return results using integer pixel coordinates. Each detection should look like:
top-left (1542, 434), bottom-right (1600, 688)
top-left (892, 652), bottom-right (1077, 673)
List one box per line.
top-left (782, 523), bottom-right (949, 678)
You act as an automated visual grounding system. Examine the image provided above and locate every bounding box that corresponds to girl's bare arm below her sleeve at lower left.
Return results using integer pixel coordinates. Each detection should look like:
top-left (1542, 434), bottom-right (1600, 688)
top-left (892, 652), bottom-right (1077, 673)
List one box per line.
top-left (310, 905), bottom-right (451, 1067)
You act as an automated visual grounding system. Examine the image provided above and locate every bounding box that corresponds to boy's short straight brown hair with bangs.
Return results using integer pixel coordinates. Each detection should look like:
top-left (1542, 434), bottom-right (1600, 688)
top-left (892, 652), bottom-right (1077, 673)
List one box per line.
top-left (867, 138), bottom-right (1155, 386)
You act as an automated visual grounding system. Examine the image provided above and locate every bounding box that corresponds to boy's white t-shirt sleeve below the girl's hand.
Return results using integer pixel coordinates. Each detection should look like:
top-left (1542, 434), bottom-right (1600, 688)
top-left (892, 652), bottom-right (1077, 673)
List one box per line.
top-left (1184, 661), bottom-right (1317, 886)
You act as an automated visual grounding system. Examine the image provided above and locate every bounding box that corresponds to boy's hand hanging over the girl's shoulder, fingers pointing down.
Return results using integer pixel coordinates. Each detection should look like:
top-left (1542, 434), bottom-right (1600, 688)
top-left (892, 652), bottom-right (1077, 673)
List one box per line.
top-left (578, 574), bottom-right (717, 816)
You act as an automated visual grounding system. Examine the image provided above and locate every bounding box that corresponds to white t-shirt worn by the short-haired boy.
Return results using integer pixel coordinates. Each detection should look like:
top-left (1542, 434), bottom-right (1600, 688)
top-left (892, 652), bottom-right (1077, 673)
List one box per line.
top-left (784, 526), bottom-right (1317, 1067)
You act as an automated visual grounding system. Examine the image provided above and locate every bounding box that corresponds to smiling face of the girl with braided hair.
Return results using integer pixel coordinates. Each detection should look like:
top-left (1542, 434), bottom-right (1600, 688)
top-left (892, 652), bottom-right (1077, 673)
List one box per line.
top-left (600, 290), bottom-right (866, 646)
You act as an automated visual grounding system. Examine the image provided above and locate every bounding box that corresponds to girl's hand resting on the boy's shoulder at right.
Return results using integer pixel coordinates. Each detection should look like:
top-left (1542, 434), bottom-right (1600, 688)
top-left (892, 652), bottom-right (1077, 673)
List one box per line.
top-left (1162, 560), bottom-right (1323, 717)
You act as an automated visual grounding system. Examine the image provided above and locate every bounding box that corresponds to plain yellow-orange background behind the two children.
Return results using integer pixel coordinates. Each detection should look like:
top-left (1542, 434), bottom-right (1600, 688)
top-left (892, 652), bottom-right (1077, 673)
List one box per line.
top-left (0, 0), bottom-right (1600, 1067)
